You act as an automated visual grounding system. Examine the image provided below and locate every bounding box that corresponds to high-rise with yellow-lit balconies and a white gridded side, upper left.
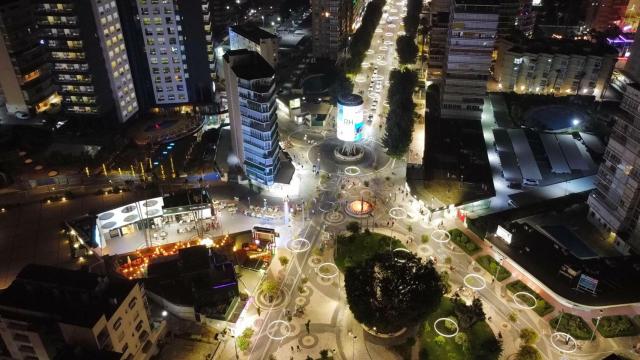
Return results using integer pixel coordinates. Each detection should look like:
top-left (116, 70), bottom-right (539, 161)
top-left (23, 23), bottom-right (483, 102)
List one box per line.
top-left (31, 0), bottom-right (138, 122)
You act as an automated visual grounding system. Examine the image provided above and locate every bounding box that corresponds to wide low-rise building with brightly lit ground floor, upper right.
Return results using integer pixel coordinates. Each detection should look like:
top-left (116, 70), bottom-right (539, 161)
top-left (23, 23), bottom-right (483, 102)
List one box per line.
top-left (494, 37), bottom-right (618, 98)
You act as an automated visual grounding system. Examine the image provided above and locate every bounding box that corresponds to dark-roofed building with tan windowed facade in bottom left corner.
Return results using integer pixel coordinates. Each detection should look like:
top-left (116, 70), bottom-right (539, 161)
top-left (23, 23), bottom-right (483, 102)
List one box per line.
top-left (0, 265), bottom-right (166, 360)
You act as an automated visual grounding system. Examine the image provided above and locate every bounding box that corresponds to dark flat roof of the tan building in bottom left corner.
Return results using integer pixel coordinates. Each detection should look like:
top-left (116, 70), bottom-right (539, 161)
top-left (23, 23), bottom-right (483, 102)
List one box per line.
top-left (0, 264), bottom-right (136, 327)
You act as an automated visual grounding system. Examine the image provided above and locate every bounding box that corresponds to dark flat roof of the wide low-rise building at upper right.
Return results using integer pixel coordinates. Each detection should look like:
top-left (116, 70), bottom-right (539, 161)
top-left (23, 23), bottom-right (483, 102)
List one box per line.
top-left (505, 33), bottom-right (618, 56)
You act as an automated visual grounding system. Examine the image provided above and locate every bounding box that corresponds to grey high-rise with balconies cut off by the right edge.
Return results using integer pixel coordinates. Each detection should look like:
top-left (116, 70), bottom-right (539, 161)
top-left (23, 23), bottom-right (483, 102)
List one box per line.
top-left (588, 83), bottom-right (640, 253)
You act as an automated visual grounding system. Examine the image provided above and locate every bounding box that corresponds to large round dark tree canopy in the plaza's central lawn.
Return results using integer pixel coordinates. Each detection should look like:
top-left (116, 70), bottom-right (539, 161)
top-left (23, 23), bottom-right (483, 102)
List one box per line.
top-left (345, 252), bottom-right (444, 333)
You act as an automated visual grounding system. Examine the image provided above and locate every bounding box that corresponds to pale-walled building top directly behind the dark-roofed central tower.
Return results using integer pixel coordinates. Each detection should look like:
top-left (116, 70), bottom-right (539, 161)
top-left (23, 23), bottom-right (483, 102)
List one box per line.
top-left (229, 25), bottom-right (279, 69)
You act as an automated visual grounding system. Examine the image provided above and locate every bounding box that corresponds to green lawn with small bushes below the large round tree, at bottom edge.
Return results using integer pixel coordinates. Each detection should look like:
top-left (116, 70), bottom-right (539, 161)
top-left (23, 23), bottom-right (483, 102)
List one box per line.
top-left (420, 298), bottom-right (500, 360)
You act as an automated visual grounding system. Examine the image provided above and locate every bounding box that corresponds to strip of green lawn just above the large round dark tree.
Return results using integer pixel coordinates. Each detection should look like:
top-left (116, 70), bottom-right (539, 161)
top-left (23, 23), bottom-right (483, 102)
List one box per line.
top-left (335, 232), bottom-right (404, 271)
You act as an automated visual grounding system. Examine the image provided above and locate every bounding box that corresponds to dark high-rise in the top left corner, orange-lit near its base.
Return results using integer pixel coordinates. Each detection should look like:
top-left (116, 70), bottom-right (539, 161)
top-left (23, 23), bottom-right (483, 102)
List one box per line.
top-left (0, 0), bottom-right (60, 116)
